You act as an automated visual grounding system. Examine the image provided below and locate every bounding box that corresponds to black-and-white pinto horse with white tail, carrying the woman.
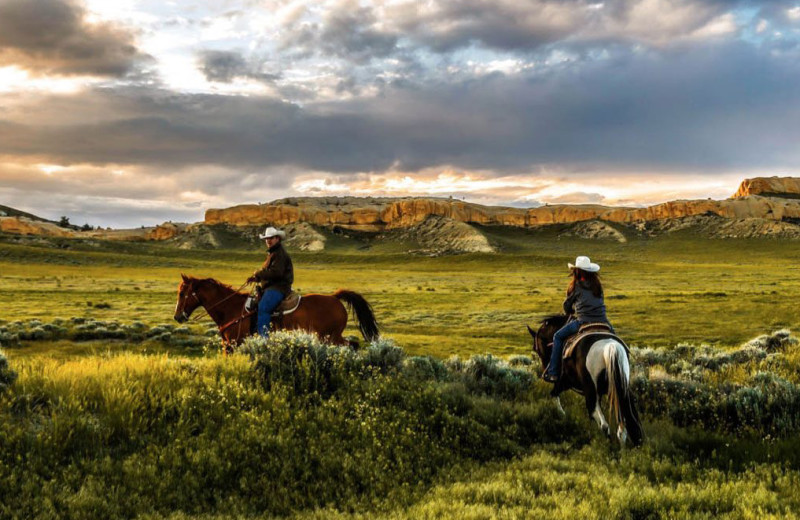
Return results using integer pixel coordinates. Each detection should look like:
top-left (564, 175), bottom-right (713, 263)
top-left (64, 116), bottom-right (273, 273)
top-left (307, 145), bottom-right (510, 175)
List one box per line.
top-left (528, 314), bottom-right (644, 446)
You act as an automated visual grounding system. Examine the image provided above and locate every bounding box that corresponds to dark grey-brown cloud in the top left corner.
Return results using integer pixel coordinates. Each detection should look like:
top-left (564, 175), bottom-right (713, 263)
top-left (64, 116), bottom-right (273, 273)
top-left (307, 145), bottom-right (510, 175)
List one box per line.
top-left (0, 0), bottom-right (147, 77)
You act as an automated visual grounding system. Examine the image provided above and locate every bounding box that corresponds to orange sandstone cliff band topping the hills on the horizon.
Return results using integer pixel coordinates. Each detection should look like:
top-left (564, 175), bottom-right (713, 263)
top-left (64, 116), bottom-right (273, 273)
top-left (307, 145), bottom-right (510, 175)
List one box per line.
top-left (205, 177), bottom-right (800, 231)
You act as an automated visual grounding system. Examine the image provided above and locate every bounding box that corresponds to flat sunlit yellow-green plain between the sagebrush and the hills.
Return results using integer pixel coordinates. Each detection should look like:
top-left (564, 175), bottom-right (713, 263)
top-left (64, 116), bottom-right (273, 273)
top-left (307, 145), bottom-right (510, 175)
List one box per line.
top-left (0, 229), bottom-right (800, 357)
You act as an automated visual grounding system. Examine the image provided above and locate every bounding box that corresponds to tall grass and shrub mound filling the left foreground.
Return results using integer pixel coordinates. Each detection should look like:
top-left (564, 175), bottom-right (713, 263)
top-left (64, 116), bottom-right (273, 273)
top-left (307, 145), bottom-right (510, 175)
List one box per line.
top-left (0, 334), bottom-right (576, 518)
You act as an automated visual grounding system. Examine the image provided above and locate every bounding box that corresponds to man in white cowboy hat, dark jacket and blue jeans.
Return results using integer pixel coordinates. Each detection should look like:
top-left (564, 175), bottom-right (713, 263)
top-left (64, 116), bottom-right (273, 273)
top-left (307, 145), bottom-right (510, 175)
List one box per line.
top-left (247, 226), bottom-right (294, 338)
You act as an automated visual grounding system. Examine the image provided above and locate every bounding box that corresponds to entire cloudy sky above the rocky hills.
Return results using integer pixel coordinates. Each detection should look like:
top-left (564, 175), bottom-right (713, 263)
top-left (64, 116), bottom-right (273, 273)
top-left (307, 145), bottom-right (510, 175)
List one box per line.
top-left (0, 0), bottom-right (800, 228)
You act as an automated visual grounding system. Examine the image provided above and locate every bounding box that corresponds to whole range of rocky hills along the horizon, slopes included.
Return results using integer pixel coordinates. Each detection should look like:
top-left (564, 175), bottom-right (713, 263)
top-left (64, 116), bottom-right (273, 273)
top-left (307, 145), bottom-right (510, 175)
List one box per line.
top-left (0, 177), bottom-right (800, 250)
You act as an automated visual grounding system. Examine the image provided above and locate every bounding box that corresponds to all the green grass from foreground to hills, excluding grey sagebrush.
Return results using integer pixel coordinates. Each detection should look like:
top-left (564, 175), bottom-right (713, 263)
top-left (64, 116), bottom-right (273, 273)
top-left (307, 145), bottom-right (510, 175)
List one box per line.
top-left (0, 228), bottom-right (800, 519)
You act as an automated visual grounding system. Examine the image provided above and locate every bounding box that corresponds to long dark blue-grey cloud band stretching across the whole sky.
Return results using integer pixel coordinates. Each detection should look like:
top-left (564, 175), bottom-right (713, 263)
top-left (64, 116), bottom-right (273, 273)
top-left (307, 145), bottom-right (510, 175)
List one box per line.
top-left (0, 39), bottom-right (800, 177)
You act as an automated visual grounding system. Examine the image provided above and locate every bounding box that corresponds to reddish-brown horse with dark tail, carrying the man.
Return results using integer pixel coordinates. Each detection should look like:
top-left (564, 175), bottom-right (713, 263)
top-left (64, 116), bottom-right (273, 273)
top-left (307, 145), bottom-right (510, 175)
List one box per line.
top-left (175, 274), bottom-right (379, 346)
